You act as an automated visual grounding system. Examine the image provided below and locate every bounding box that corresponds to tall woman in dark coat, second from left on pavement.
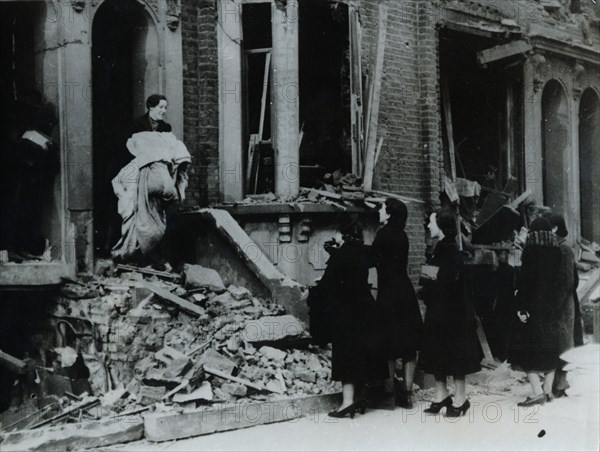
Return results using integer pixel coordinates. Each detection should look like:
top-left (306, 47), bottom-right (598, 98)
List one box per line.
top-left (371, 198), bottom-right (423, 408)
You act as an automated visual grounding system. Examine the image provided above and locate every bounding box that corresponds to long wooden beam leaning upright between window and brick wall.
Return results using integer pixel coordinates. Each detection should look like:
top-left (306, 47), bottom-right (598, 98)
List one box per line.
top-left (363, 3), bottom-right (388, 191)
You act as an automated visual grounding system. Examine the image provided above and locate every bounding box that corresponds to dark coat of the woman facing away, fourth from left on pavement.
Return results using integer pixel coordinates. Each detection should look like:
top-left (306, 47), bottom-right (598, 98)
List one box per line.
top-left (509, 231), bottom-right (574, 372)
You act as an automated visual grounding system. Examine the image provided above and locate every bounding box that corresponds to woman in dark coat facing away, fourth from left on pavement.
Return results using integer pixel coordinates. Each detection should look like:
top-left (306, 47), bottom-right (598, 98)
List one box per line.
top-left (509, 218), bottom-right (569, 406)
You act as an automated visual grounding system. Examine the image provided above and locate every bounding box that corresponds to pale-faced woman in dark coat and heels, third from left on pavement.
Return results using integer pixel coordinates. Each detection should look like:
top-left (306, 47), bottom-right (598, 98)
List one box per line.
top-left (419, 210), bottom-right (483, 417)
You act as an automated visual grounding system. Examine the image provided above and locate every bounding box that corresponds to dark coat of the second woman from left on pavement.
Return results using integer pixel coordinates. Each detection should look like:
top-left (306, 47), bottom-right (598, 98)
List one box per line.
top-left (371, 219), bottom-right (423, 360)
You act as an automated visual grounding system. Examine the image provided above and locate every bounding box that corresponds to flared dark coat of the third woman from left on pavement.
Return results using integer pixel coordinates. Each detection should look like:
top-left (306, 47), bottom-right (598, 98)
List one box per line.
top-left (419, 237), bottom-right (483, 375)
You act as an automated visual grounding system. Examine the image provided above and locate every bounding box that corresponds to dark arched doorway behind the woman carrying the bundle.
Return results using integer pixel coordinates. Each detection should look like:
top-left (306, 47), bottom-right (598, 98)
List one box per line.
top-left (92, 0), bottom-right (152, 257)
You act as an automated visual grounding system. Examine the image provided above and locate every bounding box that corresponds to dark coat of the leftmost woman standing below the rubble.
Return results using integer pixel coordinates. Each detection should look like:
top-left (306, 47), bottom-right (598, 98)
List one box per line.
top-left (319, 242), bottom-right (387, 383)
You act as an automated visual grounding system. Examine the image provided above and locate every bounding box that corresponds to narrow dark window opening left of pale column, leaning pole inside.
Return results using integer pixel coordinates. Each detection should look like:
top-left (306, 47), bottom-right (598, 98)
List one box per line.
top-left (242, 3), bottom-right (275, 194)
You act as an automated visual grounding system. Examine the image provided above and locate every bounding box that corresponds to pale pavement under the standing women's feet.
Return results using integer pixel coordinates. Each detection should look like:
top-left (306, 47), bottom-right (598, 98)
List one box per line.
top-left (105, 364), bottom-right (600, 452)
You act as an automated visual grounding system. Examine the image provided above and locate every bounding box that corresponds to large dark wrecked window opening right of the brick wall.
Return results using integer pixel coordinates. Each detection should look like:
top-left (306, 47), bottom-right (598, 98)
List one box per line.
top-left (440, 29), bottom-right (524, 231)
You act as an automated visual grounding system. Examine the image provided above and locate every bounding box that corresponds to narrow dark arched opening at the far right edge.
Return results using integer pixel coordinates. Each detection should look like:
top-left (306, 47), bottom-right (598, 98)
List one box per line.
top-left (579, 88), bottom-right (600, 243)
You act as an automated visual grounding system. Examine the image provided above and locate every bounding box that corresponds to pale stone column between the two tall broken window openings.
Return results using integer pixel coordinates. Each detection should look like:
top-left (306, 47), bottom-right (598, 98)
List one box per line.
top-left (271, 0), bottom-right (300, 199)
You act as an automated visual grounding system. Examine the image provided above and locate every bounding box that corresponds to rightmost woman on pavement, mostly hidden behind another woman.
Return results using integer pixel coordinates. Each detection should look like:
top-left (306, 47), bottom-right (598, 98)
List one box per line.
top-left (544, 212), bottom-right (583, 399)
